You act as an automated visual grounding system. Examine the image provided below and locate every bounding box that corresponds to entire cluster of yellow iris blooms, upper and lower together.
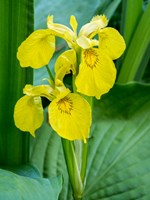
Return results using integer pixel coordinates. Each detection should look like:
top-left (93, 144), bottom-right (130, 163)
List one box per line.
top-left (14, 15), bottom-right (125, 141)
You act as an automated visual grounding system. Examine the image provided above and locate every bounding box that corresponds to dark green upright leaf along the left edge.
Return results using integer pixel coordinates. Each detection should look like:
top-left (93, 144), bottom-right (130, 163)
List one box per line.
top-left (0, 0), bottom-right (33, 165)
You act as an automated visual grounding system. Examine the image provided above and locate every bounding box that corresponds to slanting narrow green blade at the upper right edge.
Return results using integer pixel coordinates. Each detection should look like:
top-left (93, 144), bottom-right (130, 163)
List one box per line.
top-left (117, 3), bottom-right (150, 83)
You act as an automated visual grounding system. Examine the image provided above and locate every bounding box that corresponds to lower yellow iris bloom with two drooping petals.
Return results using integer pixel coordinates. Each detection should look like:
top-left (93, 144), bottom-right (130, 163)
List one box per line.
top-left (14, 82), bottom-right (91, 141)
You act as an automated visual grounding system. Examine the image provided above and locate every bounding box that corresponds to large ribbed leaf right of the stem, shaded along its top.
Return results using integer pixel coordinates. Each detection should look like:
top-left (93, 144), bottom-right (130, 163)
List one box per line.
top-left (84, 84), bottom-right (150, 199)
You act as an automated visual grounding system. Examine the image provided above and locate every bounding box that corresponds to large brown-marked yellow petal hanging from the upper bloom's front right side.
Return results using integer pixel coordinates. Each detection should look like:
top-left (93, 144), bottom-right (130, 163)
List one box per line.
top-left (75, 48), bottom-right (116, 99)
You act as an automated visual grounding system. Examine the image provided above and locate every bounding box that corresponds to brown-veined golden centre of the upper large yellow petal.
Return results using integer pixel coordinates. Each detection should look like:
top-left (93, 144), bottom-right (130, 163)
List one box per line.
top-left (84, 49), bottom-right (99, 69)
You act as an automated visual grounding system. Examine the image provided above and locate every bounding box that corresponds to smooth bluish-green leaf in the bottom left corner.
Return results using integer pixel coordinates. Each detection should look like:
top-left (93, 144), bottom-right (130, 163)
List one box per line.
top-left (0, 169), bottom-right (62, 200)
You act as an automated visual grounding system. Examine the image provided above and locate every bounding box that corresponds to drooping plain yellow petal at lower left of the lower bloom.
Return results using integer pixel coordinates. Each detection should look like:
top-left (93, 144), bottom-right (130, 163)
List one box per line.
top-left (14, 95), bottom-right (43, 136)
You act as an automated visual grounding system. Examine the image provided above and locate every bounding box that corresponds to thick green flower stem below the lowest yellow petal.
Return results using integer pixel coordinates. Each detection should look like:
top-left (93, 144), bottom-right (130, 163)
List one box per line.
top-left (62, 138), bottom-right (83, 200)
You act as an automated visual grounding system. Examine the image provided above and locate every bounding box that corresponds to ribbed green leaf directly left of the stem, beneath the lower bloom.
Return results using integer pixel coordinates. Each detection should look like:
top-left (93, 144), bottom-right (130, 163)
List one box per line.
top-left (31, 111), bottom-right (73, 200)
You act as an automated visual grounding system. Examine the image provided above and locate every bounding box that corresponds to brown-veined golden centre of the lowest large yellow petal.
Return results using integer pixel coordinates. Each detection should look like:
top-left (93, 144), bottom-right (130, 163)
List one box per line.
top-left (57, 97), bottom-right (73, 115)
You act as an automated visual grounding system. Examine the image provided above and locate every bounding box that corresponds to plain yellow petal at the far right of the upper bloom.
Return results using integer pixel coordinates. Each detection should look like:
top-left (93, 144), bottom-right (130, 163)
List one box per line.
top-left (99, 27), bottom-right (126, 60)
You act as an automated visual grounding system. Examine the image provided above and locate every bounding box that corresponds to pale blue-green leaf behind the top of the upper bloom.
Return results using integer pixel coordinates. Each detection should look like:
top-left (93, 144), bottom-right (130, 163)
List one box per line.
top-left (35, 0), bottom-right (103, 29)
